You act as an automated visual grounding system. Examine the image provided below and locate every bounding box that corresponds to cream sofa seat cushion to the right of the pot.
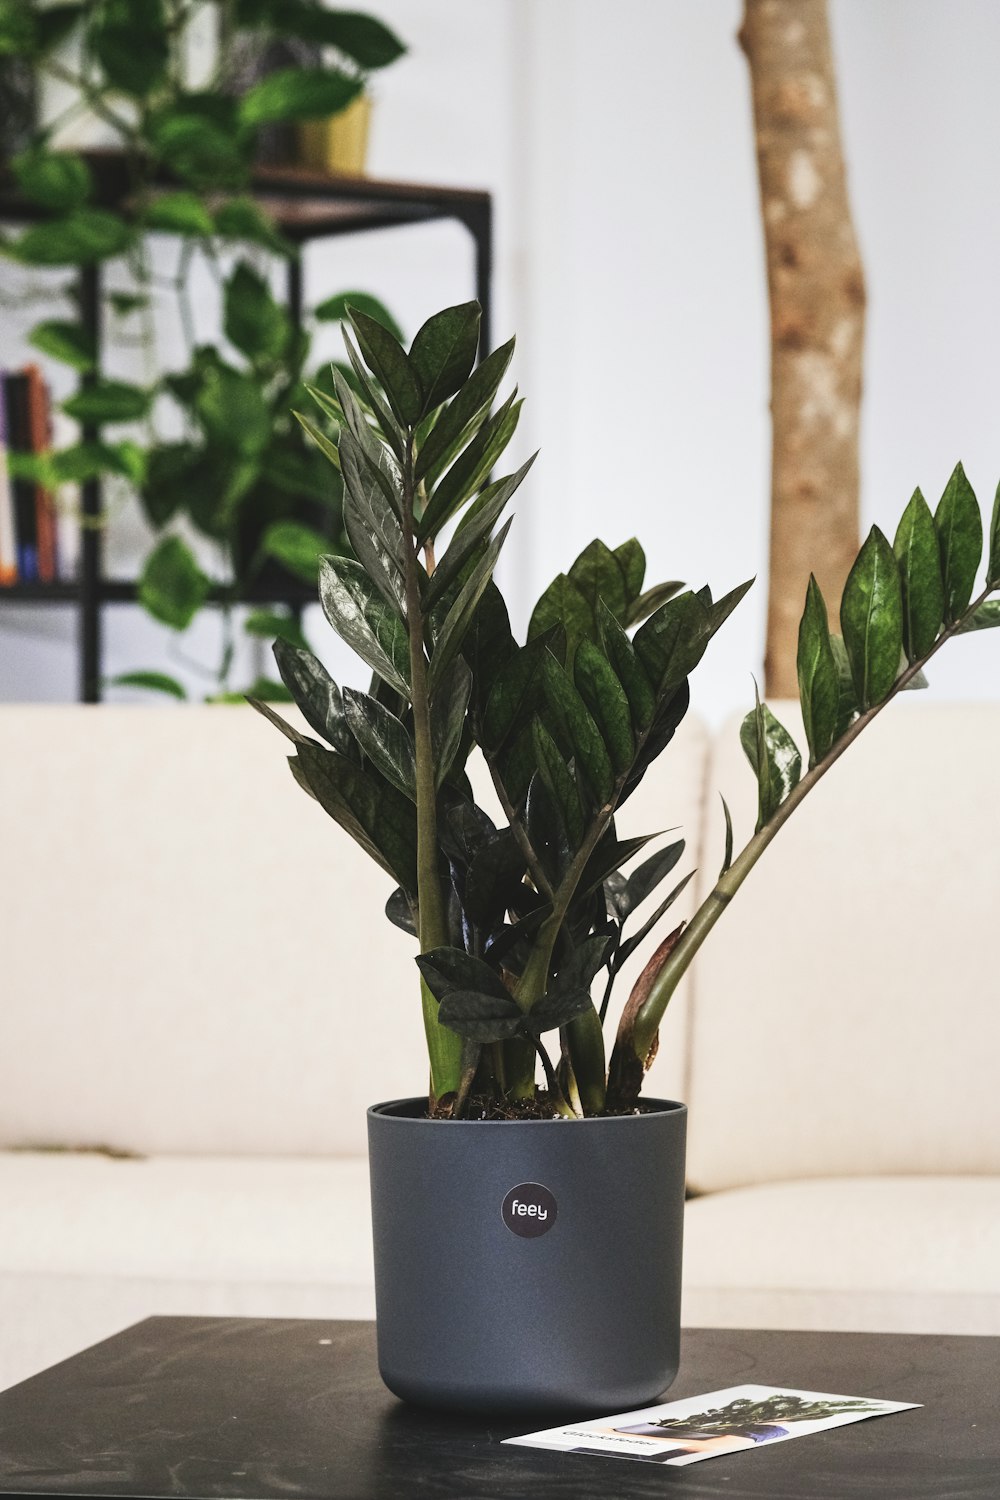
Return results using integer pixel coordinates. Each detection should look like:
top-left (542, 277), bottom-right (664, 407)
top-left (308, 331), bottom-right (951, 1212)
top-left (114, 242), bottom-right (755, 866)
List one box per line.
top-left (682, 1176), bottom-right (1000, 1335)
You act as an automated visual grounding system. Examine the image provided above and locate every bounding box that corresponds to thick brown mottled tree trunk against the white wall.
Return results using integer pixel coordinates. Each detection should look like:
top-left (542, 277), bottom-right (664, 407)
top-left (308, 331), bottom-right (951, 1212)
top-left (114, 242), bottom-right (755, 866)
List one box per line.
top-left (739, 0), bottom-right (865, 698)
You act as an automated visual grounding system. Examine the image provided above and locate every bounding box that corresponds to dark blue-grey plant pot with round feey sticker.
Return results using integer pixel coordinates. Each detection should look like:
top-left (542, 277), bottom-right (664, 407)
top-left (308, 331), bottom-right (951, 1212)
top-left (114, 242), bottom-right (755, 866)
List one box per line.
top-left (367, 1100), bottom-right (687, 1416)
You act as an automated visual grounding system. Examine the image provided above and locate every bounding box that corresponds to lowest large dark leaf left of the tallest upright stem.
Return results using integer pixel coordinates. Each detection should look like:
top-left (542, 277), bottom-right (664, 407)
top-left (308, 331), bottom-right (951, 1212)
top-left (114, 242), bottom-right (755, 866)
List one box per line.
top-left (295, 744), bottom-right (417, 897)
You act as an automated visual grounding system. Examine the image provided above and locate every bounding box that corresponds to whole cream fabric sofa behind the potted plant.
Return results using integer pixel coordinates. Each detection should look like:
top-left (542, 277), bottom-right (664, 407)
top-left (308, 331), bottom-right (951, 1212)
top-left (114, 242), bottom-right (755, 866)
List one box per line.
top-left (0, 695), bottom-right (1000, 1386)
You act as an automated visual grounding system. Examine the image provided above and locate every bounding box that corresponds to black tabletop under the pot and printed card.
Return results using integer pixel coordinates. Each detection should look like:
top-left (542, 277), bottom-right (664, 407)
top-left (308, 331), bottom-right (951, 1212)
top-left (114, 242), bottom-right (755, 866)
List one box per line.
top-left (0, 1317), bottom-right (1000, 1500)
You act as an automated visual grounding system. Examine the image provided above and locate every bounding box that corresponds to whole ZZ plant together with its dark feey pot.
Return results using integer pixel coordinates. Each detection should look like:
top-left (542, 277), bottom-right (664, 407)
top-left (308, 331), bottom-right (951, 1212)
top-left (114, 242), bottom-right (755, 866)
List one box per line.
top-left (255, 303), bottom-right (1000, 1412)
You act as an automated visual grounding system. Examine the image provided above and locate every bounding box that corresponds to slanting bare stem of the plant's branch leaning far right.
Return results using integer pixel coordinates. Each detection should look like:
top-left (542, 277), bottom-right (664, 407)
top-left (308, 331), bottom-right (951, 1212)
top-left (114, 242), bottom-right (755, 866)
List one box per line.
top-left (612, 585), bottom-right (996, 1103)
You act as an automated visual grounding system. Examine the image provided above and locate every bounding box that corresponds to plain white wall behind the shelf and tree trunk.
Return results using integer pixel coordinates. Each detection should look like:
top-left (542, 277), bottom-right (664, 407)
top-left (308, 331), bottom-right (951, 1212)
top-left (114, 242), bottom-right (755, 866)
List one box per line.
top-left (0, 0), bottom-right (1000, 717)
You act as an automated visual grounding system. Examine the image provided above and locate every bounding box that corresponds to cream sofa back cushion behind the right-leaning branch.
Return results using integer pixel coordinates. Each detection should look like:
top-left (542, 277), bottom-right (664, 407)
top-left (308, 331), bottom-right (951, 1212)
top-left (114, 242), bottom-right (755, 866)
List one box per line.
top-left (688, 693), bottom-right (1000, 1190)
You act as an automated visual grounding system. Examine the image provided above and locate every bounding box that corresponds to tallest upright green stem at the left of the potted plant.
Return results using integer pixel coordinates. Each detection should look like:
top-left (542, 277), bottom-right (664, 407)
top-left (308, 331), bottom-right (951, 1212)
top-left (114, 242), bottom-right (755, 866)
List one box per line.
top-left (402, 431), bottom-right (462, 1110)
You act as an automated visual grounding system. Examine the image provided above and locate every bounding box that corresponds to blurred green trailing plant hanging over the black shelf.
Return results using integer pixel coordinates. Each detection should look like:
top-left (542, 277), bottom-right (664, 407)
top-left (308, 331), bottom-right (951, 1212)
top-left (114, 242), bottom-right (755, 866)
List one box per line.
top-left (0, 0), bottom-right (405, 699)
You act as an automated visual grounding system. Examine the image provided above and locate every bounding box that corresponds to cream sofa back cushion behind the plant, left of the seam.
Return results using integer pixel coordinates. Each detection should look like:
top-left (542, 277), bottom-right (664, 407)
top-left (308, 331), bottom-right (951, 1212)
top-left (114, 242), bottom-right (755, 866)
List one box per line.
top-left (0, 705), bottom-right (706, 1154)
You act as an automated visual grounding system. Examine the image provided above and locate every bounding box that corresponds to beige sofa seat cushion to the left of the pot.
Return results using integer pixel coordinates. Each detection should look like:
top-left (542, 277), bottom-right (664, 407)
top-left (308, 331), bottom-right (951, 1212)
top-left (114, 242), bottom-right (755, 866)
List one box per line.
top-left (0, 1152), bottom-right (375, 1389)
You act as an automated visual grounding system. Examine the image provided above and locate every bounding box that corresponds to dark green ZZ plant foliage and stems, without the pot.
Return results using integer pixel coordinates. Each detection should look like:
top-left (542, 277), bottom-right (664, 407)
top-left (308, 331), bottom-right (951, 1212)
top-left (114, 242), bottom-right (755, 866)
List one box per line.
top-left (255, 303), bottom-right (1000, 1118)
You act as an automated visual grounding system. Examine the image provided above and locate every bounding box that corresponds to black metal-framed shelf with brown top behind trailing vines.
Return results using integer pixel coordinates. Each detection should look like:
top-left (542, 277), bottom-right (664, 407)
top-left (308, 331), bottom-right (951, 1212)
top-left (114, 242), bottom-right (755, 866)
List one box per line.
top-left (0, 152), bottom-right (493, 704)
